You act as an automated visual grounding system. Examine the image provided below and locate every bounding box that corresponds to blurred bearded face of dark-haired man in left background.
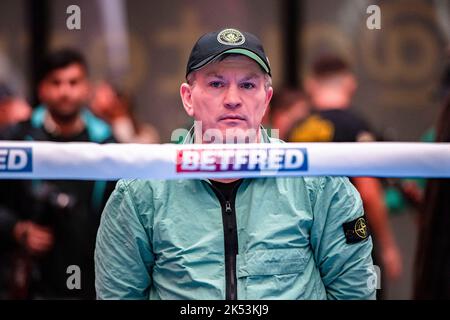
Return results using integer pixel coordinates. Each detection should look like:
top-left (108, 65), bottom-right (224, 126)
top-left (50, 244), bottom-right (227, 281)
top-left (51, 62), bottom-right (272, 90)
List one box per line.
top-left (39, 63), bottom-right (89, 121)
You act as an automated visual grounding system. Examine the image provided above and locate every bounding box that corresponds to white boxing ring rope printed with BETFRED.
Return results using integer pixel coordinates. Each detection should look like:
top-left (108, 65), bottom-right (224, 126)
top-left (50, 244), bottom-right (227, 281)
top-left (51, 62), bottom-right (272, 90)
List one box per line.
top-left (0, 141), bottom-right (450, 180)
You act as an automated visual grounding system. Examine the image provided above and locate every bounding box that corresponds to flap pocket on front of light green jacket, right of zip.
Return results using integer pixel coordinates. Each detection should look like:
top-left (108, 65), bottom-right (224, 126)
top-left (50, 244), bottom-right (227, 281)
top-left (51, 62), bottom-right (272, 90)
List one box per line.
top-left (236, 248), bottom-right (311, 300)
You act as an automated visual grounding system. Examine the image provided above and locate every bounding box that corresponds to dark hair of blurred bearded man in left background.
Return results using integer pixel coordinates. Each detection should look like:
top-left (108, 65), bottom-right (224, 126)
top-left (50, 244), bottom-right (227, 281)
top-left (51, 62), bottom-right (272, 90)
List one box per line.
top-left (38, 48), bottom-right (88, 81)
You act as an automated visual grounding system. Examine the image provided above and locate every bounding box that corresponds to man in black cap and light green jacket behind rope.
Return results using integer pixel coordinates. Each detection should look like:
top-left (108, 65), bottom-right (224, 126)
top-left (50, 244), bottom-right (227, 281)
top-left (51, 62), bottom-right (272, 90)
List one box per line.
top-left (95, 29), bottom-right (374, 300)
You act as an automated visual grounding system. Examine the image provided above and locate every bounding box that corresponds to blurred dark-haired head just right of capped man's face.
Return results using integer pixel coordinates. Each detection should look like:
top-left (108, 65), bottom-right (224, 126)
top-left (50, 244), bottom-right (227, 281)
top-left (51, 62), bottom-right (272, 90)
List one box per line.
top-left (263, 88), bottom-right (310, 141)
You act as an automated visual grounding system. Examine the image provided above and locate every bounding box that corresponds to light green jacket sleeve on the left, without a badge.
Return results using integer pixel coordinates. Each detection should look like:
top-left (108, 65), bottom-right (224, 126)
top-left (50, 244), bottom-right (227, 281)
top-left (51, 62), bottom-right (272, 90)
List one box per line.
top-left (95, 180), bottom-right (154, 299)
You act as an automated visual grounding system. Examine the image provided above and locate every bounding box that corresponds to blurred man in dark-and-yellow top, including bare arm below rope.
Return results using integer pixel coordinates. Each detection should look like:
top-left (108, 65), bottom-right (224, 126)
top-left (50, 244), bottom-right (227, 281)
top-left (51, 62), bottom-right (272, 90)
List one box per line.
top-left (289, 55), bottom-right (402, 294)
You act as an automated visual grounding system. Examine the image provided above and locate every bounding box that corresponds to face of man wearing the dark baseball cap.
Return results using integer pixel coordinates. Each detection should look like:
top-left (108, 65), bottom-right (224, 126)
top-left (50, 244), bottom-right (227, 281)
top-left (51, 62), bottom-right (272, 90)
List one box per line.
top-left (181, 55), bottom-right (272, 142)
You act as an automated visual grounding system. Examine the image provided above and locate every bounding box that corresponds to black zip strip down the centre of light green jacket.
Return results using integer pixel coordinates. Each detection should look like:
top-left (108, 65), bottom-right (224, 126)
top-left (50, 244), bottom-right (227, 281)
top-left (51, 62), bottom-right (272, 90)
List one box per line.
top-left (210, 183), bottom-right (240, 300)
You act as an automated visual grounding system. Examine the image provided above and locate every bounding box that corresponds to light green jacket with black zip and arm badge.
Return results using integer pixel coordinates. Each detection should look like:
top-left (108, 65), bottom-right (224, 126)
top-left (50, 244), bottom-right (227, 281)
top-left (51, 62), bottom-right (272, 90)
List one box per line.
top-left (95, 129), bottom-right (376, 300)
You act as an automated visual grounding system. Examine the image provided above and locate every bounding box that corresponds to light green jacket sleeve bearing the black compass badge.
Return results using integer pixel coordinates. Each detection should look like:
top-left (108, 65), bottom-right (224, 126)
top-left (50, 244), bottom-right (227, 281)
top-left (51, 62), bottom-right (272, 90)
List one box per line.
top-left (311, 177), bottom-right (377, 299)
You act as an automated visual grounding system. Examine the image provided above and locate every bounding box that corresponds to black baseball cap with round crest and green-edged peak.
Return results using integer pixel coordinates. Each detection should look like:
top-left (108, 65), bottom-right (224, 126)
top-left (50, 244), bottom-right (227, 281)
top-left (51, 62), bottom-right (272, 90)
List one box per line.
top-left (186, 28), bottom-right (271, 77)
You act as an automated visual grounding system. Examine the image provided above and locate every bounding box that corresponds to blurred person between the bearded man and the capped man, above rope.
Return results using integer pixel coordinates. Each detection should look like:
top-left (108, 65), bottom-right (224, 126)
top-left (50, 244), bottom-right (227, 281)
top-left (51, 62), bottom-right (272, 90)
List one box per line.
top-left (89, 82), bottom-right (160, 143)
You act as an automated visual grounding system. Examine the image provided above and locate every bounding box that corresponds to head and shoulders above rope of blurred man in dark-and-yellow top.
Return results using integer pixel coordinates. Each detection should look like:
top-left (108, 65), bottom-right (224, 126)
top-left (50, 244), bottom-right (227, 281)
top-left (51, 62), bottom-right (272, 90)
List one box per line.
top-left (289, 55), bottom-right (375, 142)
